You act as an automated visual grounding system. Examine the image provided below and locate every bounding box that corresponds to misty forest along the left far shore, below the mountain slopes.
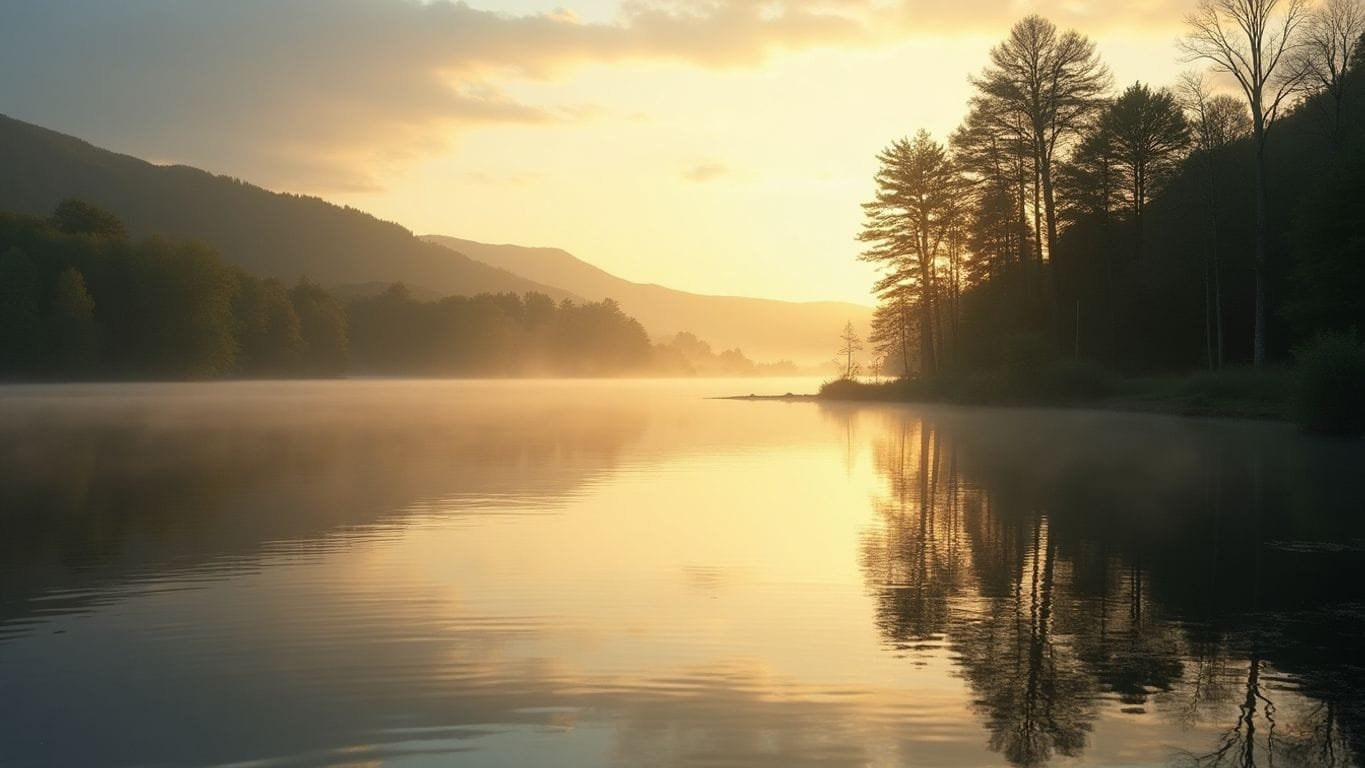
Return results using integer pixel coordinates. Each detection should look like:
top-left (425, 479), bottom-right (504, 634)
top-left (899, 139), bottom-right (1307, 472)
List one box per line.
top-left (0, 199), bottom-right (788, 379)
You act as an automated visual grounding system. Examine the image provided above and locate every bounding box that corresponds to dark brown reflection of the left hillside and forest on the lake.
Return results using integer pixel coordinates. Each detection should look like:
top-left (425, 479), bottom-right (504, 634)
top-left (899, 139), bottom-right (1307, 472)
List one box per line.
top-left (0, 382), bottom-right (644, 641)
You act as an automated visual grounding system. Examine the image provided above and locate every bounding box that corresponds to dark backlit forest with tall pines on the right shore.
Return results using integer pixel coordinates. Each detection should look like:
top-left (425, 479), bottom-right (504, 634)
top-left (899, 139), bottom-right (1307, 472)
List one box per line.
top-left (860, 0), bottom-right (1365, 395)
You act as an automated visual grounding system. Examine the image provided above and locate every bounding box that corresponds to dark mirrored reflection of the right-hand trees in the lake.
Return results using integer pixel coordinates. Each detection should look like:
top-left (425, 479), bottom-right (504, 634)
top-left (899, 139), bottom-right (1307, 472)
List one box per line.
top-left (834, 409), bottom-right (1365, 767)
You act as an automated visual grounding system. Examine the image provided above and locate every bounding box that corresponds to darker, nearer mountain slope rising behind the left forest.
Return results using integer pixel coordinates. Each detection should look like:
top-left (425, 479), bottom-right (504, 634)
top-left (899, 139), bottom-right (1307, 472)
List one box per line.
top-left (0, 115), bottom-right (569, 299)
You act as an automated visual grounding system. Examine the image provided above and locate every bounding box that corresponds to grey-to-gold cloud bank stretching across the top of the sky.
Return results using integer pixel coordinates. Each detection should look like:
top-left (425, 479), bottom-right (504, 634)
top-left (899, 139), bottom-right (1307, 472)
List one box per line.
top-left (0, 0), bottom-right (1178, 191)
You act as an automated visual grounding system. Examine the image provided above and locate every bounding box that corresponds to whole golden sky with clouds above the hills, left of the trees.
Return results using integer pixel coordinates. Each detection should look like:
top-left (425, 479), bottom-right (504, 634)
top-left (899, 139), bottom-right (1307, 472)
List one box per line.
top-left (0, 0), bottom-right (1193, 303)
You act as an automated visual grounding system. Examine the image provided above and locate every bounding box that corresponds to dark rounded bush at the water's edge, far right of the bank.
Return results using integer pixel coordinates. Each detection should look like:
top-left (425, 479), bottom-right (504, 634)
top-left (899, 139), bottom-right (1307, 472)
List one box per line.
top-left (1294, 333), bottom-right (1365, 434)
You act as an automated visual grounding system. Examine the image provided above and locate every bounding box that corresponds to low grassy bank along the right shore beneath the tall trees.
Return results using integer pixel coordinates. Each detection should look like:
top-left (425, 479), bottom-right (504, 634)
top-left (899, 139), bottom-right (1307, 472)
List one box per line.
top-left (819, 337), bottom-right (1365, 434)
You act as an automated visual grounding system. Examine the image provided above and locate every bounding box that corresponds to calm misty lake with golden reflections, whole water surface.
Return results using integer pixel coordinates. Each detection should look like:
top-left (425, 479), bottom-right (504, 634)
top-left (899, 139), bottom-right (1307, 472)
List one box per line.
top-left (0, 381), bottom-right (1365, 767)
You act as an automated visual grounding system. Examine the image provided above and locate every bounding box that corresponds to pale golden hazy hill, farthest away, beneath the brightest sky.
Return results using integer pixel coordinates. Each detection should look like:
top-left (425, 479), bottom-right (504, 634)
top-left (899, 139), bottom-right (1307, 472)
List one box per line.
top-left (423, 235), bottom-right (872, 364)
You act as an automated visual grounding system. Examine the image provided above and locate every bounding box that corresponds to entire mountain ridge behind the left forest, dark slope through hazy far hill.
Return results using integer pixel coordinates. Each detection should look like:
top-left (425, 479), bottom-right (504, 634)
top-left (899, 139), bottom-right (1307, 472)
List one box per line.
top-left (0, 115), bottom-right (872, 364)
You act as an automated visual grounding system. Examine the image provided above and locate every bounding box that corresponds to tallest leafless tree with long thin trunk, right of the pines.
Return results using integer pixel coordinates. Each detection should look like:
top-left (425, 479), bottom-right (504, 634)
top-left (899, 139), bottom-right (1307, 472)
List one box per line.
top-left (1181, 0), bottom-right (1309, 368)
